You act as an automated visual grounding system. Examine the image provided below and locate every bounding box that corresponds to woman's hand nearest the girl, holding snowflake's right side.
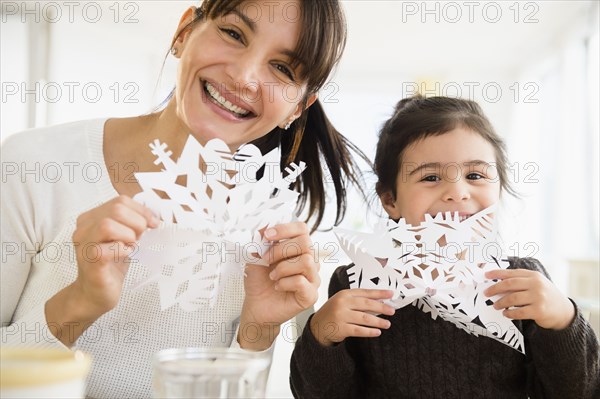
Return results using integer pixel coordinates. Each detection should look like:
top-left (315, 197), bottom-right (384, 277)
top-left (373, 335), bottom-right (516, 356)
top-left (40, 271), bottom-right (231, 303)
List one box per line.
top-left (238, 222), bottom-right (321, 350)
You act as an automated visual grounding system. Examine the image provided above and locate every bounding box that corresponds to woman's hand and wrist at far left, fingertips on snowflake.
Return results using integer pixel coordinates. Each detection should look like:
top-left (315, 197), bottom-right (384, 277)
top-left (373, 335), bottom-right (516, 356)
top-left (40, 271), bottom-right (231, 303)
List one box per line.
top-left (46, 195), bottom-right (159, 345)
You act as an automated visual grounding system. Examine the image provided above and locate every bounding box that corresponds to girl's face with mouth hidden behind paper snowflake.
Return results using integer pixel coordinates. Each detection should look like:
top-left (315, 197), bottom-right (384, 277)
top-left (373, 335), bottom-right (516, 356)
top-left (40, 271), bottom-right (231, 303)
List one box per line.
top-left (380, 128), bottom-right (500, 225)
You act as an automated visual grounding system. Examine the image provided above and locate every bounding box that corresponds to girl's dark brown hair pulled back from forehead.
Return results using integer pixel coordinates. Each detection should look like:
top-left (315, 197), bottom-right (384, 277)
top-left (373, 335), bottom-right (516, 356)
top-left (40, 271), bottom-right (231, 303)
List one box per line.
top-left (374, 95), bottom-right (516, 198)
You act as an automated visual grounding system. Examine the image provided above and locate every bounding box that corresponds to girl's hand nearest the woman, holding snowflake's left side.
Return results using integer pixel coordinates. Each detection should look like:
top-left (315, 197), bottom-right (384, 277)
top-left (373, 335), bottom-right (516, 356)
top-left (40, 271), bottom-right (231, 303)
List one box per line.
top-left (310, 288), bottom-right (395, 346)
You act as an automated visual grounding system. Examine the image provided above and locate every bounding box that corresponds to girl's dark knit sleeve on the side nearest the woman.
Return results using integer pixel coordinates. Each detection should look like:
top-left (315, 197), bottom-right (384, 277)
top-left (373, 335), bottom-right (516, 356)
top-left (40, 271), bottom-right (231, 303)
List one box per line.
top-left (290, 266), bottom-right (359, 399)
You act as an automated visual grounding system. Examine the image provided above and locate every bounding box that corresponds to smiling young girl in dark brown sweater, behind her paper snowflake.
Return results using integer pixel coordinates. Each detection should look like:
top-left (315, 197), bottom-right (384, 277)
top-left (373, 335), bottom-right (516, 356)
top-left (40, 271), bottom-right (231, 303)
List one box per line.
top-left (290, 96), bottom-right (600, 399)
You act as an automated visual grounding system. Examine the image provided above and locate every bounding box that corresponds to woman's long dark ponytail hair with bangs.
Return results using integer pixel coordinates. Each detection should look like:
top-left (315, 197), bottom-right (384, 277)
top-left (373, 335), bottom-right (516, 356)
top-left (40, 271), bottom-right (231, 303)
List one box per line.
top-left (165, 0), bottom-right (371, 231)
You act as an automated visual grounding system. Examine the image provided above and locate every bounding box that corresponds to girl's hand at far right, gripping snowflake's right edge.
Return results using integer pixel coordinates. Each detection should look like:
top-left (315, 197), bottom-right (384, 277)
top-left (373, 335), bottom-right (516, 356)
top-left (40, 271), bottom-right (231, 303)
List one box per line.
top-left (484, 269), bottom-right (575, 330)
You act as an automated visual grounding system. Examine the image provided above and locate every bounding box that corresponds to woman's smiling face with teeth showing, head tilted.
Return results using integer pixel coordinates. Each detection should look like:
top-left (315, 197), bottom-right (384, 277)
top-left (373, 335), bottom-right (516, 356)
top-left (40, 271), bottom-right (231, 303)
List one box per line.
top-left (174, 1), bottom-right (316, 149)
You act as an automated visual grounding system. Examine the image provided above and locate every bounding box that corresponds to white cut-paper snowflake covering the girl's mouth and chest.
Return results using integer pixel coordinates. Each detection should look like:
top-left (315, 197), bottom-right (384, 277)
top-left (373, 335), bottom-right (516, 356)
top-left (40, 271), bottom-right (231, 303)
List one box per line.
top-left (334, 205), bottom-right (525, 353)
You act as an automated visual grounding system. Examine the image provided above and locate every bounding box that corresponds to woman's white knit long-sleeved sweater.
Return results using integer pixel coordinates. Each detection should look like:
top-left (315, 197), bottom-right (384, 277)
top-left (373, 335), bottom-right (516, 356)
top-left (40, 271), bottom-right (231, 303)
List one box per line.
top-left (0, 119), bottom-right (244, 398)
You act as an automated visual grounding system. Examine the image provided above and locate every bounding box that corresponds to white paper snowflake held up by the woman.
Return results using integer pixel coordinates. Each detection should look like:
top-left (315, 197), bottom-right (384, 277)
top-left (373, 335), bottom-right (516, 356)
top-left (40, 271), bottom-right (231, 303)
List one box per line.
top-left (131, 135), bottom-right (306, 311)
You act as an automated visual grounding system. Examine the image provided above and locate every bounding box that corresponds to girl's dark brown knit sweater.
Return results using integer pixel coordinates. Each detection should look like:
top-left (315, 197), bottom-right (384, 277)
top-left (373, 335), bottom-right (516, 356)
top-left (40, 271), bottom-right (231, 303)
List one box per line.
top-left (290, 258), bottom-right (600, 399)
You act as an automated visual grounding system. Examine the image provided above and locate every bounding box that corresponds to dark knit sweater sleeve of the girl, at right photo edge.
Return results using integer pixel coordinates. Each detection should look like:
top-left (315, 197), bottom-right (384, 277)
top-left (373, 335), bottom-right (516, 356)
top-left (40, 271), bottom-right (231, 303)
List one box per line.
top-left (515, 258), bottom-right (600, 399)
